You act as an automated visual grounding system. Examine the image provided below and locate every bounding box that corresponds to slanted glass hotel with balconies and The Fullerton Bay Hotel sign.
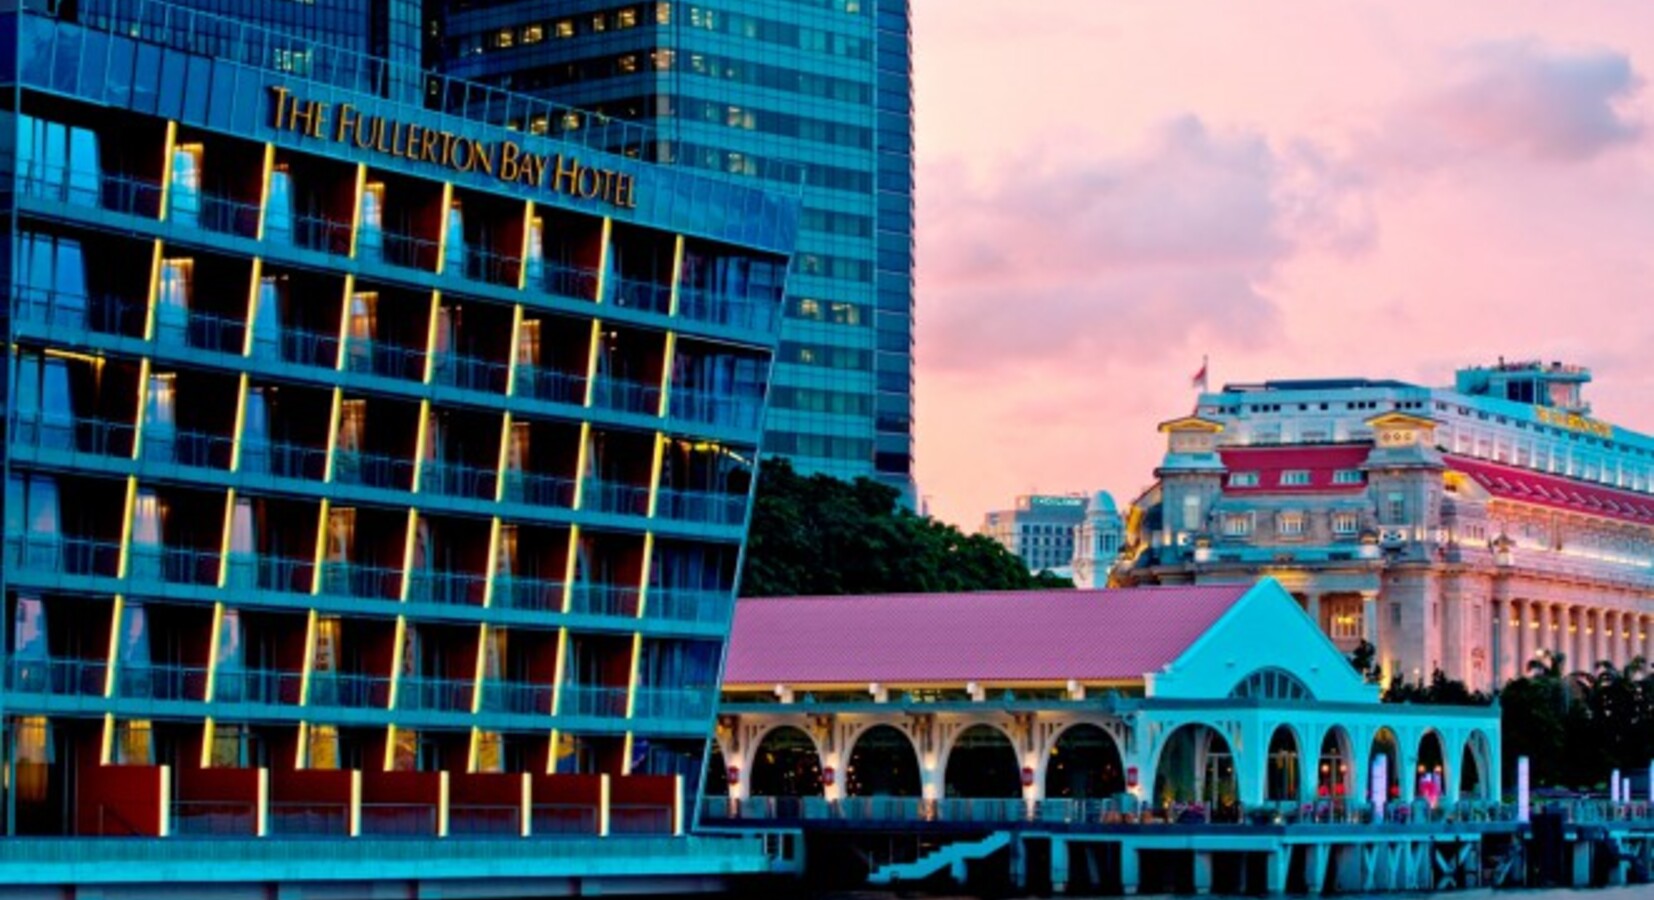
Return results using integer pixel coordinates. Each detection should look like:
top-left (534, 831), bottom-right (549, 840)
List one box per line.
top-left (0, 0), bottom-right (799, 837)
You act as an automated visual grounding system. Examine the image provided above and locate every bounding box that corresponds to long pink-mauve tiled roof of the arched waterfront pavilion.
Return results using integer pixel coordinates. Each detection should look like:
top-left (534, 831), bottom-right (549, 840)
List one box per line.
top-left (724, 584), bottom-right (1250, 687)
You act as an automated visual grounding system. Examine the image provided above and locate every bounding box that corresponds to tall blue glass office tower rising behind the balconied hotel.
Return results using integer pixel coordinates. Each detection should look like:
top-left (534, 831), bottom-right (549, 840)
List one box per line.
top-left (425, 0), bottom-right (913, 498)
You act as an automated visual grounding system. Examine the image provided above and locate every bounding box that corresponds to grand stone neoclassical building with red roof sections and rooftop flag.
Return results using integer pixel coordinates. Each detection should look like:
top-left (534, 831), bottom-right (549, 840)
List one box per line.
top-left (1092, 361), bottom-right (1654, 690)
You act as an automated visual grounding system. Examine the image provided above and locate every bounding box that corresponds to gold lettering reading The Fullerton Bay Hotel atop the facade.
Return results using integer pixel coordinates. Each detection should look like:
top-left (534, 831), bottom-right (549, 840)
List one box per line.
top-left (270, 86), bottom-right (637, 208)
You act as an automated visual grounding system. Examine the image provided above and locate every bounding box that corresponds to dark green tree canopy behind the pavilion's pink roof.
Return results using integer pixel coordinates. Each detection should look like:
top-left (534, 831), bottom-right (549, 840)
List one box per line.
top-left (741, 458), bottom-right (1072, 597)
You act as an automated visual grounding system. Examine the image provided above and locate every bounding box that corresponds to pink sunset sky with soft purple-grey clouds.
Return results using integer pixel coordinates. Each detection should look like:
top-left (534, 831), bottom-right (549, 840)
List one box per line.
top-left (913, 0), bottom-right (1654, 528)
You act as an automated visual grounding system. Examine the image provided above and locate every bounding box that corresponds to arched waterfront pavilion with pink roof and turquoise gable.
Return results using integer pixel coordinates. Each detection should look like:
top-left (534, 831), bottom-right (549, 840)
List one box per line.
top-left (701, 579), bottom-right (1500, 819)
